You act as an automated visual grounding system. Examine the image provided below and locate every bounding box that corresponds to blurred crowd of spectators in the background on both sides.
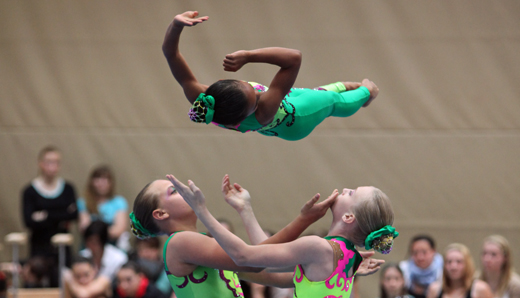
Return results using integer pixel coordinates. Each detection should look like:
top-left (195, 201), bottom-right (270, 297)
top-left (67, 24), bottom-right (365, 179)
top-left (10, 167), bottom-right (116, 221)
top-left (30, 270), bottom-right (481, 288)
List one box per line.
top-left (0, 146), bottom-right (520, 298)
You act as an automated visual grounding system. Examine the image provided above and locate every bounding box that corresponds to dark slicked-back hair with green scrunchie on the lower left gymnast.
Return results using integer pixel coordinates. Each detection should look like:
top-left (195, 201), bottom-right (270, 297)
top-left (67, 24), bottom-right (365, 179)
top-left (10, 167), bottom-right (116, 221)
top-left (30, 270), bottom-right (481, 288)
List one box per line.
top-left (130, 182), bottom-right (160, 239)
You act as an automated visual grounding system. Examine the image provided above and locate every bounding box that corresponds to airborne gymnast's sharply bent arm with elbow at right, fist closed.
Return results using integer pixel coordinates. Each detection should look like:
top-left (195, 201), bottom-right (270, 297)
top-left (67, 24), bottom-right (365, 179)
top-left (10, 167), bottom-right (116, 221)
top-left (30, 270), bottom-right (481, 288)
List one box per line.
top-left (224, 47), bottom-right (302, 125)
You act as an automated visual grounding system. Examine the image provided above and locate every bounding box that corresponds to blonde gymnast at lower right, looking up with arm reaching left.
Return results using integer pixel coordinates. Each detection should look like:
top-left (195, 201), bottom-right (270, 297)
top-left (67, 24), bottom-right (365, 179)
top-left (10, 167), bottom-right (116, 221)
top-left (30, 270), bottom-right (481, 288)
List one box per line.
top-left (167, 175), bottom-right (399, 298)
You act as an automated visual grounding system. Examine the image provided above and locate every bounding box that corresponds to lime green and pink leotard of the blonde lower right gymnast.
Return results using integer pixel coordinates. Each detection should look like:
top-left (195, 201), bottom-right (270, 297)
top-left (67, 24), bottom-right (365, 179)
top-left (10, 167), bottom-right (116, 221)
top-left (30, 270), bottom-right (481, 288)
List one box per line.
top-left (293, 236), bottom-right (363, 298)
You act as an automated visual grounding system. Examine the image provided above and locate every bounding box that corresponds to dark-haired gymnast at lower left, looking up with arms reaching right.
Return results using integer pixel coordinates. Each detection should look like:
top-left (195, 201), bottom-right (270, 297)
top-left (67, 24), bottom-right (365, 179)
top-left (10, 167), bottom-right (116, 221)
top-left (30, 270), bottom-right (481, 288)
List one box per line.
top-left (130, 175), bottom-right (335, 298)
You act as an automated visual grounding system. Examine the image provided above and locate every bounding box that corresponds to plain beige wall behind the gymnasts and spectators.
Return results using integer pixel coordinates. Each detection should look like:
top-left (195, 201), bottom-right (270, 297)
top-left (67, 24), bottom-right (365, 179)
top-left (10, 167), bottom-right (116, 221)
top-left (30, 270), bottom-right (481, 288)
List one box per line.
top-left (0, 0), bottom-right (520, 297)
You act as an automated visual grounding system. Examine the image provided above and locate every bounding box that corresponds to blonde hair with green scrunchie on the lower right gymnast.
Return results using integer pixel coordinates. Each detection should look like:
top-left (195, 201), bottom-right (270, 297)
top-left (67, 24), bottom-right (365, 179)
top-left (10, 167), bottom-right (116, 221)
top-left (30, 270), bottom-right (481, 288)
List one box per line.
top-left (352, 188), bottom-right (399, 254)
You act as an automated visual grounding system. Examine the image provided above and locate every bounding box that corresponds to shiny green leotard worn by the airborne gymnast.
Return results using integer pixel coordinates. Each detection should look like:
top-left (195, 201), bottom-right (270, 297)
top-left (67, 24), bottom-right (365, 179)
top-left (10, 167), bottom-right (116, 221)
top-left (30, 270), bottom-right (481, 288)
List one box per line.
top-left (217, 82), bottom-right (370, 141)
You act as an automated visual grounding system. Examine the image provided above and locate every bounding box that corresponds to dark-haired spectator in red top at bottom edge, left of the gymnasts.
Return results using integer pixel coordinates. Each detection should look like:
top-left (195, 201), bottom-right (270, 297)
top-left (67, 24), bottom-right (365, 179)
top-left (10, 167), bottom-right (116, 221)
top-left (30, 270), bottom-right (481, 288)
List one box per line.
top-left (114, 261), bottom-right (168, 298)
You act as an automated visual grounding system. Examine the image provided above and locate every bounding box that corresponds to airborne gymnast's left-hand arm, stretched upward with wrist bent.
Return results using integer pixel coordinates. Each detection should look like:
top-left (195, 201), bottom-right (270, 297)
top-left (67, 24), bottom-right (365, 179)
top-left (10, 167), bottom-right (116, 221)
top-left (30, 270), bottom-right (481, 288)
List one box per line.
top-left (162, 11), bottom-right (208, 103)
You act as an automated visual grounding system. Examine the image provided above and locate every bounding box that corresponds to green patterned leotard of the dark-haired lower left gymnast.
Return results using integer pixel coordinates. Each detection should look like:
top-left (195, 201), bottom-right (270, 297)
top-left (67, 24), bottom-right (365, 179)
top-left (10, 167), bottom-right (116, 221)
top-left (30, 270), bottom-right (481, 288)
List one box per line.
top-left (163, 232), bottom-right (244, 298)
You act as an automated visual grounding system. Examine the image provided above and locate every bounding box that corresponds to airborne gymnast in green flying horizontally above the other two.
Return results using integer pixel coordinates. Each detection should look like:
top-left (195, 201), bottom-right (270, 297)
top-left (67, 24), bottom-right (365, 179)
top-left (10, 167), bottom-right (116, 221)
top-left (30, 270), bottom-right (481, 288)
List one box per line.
top-left (163, 11), bottom-right (379, 141)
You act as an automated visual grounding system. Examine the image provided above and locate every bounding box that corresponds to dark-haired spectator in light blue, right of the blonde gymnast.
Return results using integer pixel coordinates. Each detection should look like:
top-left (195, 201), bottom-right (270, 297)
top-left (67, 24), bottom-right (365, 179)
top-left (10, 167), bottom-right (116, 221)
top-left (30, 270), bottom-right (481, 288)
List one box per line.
top-left (399, 235), bottom-right (443, 298)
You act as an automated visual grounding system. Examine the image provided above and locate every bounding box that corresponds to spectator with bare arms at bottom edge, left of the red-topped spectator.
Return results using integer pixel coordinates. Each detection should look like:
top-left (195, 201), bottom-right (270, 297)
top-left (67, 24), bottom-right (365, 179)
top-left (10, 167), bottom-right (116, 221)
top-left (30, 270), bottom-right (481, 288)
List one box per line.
top-left (63, 257), bottom-right (112, 298)
